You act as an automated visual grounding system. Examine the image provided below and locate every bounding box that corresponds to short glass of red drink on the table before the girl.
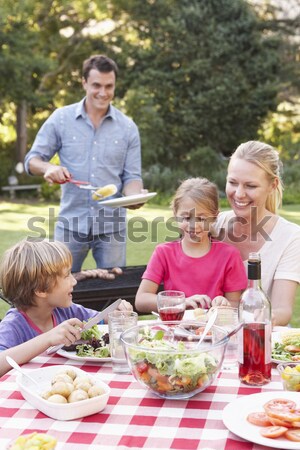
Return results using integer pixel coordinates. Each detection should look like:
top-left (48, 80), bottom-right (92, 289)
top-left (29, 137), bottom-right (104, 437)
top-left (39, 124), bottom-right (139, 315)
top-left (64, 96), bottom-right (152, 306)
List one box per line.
top-left (157, 290), bottom-right (185, 321)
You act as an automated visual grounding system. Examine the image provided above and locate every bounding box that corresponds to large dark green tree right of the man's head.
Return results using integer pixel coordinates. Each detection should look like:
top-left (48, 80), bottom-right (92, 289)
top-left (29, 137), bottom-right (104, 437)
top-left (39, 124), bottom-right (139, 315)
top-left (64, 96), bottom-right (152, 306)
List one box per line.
top-left (112, 0), bottom-right (280, 168)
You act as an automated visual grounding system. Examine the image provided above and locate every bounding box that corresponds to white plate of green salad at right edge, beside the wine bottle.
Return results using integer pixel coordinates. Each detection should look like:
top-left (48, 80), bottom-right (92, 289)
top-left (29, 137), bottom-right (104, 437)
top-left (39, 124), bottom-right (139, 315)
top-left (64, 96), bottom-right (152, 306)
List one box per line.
top-left (272, 327), bottom-right (300, 364)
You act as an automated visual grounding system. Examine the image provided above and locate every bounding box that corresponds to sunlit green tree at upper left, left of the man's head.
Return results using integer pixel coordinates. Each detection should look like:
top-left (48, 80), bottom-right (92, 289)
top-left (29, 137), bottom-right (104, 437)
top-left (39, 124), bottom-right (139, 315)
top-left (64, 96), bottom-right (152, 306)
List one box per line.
top-left (0, 0), bottom-right (110, 165)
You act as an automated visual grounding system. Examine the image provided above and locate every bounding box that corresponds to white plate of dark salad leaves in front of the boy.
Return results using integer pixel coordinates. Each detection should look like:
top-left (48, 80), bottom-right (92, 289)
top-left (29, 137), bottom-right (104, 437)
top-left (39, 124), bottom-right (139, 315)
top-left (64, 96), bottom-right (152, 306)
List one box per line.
top-left (57, 325), bottom-right (111, 363)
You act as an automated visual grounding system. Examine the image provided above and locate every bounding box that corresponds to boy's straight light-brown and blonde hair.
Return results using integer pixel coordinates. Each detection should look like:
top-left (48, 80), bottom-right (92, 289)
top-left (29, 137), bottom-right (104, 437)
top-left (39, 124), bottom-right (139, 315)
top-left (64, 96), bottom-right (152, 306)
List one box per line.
top-left (0, 239), bottom-right (72, 311)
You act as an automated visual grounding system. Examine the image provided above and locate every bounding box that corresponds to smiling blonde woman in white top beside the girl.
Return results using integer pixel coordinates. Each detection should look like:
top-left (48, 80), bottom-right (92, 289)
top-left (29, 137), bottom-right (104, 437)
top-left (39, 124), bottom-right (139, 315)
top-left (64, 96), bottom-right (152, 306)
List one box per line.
top-left (215, 141), bottom-right (300, 325)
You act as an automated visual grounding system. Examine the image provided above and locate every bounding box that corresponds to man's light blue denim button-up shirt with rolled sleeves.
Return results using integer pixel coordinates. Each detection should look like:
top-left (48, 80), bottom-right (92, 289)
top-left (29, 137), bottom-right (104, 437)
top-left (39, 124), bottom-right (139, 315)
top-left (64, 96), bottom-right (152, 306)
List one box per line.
top-left (25, 98), bottom-right (141, 235)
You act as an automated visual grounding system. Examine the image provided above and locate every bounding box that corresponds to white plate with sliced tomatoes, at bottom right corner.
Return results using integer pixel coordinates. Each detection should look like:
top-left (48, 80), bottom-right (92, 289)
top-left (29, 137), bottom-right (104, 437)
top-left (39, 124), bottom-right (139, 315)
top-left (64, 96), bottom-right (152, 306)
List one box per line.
top-left (222, 391), bottom-right (300, 450)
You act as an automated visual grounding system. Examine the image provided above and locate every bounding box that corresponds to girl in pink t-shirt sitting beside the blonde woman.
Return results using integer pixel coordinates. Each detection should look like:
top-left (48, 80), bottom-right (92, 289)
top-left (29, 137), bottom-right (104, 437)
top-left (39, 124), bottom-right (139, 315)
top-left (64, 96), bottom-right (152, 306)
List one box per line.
top-left (135, 178), bottom-right (247, 312)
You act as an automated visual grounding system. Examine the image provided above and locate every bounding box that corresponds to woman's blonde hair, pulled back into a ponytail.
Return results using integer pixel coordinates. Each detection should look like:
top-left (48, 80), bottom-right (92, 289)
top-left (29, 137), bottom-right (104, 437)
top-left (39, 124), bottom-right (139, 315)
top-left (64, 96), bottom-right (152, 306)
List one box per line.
top-left (230, 141), bottom-right (283, 213)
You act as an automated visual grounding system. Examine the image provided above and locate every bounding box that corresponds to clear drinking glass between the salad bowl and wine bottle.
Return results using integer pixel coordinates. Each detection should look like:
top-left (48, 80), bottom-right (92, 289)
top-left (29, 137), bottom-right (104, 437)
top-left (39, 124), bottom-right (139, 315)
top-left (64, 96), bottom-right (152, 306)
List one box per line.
top-left (215, 306), bottom-right (239, 370)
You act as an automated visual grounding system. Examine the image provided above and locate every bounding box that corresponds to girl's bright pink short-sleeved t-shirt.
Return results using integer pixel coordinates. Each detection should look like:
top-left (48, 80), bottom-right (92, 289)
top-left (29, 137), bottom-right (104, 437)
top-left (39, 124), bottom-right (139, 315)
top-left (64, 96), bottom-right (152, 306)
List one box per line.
top-left (142, 241), bottom-right (247, 299)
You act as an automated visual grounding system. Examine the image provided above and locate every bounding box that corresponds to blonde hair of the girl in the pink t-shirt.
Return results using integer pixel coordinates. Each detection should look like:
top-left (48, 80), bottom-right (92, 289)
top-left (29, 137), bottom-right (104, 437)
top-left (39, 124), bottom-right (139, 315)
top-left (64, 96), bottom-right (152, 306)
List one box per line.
top-left (171, 177), bottom-right (219, 218)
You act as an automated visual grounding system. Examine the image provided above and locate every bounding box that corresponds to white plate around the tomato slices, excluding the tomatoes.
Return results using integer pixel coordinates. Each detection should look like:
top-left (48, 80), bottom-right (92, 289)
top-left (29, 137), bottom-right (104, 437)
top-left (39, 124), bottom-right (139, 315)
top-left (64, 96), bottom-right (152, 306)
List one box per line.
top-left (222, 391), bottom-right (300, 450)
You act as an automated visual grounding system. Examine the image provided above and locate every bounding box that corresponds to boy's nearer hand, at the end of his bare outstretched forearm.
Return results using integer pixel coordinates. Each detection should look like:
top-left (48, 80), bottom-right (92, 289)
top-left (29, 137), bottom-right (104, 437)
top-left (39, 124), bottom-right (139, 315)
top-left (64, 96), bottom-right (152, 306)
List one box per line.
top-left (48, 317), bottom-right (84, 346)
